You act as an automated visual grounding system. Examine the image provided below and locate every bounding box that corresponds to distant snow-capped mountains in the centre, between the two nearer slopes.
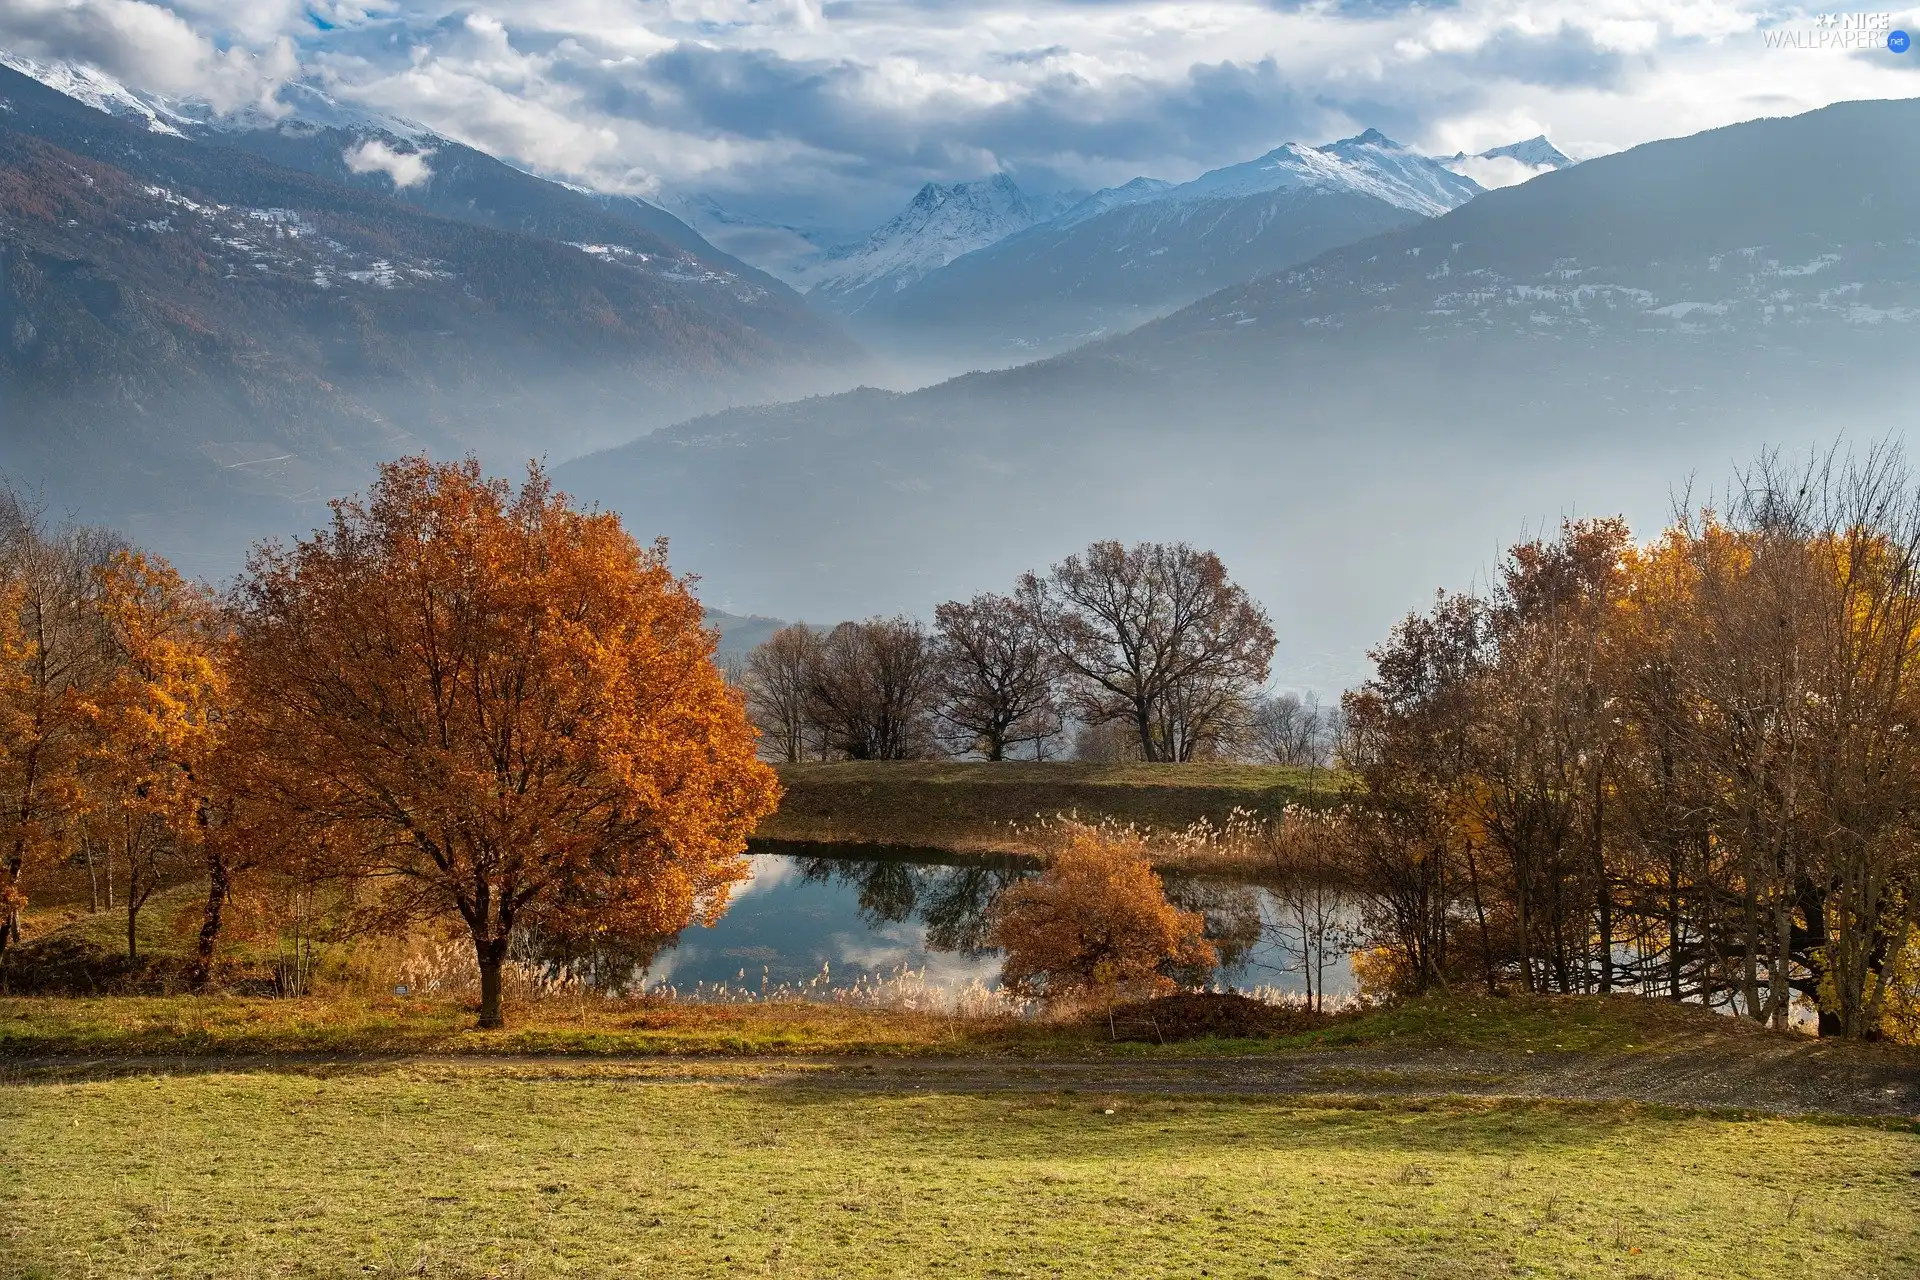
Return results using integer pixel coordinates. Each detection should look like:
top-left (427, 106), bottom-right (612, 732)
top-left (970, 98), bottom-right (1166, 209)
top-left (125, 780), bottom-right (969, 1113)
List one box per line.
top-left (668, 129), bottom-right (1572, 372)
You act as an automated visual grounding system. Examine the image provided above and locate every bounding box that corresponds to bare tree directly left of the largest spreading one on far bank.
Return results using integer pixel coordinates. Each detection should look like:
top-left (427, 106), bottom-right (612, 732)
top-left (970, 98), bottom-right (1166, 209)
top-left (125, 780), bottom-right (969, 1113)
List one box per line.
top-left (933, 593), bottom-right (1062, 760)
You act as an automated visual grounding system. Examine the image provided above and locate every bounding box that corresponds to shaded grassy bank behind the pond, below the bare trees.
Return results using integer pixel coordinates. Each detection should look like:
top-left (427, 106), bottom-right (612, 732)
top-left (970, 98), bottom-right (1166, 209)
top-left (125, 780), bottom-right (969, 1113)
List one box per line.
top-left (756, 760), bottom-right (1348, 852)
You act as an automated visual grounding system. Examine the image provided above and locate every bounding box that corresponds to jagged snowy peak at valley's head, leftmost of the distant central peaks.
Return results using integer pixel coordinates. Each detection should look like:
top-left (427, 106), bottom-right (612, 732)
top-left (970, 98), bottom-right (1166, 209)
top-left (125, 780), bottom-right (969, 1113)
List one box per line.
top-left (806, 173), bottom-right (1048, 315)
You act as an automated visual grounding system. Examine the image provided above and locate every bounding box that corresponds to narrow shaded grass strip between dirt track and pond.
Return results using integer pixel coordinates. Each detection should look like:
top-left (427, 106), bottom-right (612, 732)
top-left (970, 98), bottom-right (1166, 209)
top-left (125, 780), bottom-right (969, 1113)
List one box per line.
top-left (0, 996), bottom-right (1797, 1057)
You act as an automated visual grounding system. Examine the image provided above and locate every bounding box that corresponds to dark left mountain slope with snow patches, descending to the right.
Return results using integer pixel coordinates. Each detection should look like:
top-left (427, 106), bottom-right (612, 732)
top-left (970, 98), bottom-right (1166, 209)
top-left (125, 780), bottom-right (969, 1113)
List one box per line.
top-left (0, 55), bottom-right (862, 564)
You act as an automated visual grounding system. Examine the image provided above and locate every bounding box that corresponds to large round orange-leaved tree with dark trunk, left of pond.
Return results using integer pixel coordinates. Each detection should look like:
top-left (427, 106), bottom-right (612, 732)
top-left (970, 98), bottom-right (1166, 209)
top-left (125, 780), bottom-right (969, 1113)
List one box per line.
top-left (236, 459), bottom-right (778, 1027)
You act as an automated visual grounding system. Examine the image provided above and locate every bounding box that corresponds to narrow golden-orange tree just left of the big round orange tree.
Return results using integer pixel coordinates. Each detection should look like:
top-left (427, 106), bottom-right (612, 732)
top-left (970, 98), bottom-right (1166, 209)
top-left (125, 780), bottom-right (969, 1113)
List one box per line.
top-left (81, 551), bottom-right (228, 959)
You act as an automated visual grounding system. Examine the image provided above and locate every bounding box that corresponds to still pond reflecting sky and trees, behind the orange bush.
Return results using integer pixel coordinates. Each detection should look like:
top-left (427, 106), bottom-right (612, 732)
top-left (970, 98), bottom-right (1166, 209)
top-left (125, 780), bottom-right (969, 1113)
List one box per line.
top-left (622, 846), bottom-right (1354, 998)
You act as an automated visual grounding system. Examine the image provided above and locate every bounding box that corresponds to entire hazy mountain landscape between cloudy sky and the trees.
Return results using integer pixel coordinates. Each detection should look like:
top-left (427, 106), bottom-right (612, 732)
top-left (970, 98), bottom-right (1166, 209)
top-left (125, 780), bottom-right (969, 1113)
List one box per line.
top-left (0, 47), bottom-right (1920, 691)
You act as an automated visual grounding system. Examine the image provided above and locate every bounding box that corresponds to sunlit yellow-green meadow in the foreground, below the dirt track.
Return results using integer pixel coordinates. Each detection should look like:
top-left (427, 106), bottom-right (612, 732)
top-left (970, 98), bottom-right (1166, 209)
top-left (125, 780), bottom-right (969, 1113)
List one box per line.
top-left (0, 1065), bottom-right (1920, 1280)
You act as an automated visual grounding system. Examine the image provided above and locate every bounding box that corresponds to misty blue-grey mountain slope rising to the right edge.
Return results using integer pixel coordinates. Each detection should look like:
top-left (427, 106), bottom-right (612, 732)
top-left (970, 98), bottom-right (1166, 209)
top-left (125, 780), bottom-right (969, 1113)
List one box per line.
top-left (561, 102), bottom-right (1920, 689)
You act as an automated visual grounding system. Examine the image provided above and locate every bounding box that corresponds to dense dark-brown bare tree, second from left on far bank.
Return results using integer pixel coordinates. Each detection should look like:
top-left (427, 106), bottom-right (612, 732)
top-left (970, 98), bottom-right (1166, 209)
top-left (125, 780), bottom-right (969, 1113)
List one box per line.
top-left (806, 618), bottom-right (939, 760)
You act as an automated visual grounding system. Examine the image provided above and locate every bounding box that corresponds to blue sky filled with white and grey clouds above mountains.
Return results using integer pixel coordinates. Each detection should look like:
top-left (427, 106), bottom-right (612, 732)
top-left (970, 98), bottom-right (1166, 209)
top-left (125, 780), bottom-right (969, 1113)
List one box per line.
top-left (0, 0), bottom-right (1920, 228)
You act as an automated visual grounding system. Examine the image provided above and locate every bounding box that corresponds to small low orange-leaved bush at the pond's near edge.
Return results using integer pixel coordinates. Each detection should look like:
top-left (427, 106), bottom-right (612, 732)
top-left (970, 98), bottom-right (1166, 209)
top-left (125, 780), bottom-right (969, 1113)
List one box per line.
top-left (987, 825), bottom-right (1217, 1004)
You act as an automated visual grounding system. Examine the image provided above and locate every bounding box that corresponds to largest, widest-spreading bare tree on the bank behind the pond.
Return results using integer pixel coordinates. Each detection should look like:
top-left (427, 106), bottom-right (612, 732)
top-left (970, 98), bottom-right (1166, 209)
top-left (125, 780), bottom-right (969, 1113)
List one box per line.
top-left (1020, 541), bottom-right (1275, 760)
